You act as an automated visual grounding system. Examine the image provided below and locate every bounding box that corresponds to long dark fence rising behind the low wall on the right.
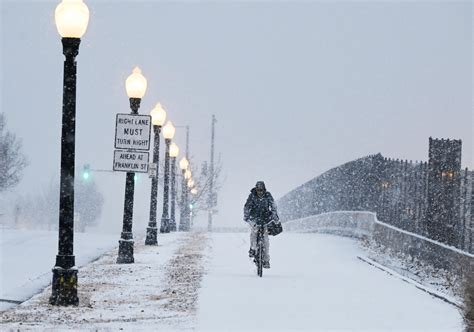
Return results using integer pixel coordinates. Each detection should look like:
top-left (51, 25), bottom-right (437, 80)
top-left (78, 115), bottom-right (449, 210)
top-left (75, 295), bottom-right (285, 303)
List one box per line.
top-left (278, 150), bottom-right (474, 253)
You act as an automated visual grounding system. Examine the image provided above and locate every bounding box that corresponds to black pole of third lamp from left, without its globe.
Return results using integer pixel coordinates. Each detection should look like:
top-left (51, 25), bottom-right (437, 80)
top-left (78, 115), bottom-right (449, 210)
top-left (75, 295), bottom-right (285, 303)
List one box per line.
top-left (145, 125), bottom-right (161, 246)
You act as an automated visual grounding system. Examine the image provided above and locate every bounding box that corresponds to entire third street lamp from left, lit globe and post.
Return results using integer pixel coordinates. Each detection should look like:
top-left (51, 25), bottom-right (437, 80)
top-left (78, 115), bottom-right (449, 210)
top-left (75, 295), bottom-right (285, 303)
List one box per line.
top-left (145, 103), bottom-right (166, 246)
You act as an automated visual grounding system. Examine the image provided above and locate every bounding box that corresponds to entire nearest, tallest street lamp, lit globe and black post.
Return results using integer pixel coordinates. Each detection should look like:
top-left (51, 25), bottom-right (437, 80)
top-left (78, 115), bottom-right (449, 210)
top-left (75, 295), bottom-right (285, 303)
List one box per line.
top-left (49, 0), bottom-right (89, 305)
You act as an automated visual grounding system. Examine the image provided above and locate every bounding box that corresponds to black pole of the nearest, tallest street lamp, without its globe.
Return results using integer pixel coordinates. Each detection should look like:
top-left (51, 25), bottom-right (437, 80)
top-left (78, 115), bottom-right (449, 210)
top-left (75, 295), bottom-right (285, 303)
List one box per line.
top-left (49, 38), bottom-right (81, 305)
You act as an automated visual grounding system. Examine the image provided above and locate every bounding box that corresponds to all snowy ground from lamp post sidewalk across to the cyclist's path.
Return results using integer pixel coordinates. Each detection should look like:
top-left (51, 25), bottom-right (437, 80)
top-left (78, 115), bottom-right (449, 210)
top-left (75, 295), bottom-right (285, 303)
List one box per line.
top-left (0, 232), bottom-right (462, 331)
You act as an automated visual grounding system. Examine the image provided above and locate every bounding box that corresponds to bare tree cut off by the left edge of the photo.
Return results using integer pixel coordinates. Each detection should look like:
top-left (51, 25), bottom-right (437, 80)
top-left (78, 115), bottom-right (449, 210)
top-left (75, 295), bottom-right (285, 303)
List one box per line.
top-left (0, 113), bottom-right (27, 192)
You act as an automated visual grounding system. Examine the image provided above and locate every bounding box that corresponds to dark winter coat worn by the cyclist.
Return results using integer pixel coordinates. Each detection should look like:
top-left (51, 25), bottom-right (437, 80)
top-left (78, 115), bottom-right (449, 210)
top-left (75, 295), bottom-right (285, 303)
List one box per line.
top-left (244, 188), bottom-right (279, 224)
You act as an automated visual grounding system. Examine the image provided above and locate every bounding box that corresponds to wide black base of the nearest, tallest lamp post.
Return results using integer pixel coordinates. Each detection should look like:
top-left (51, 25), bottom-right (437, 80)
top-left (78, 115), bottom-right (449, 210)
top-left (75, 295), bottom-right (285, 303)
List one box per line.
top-left (49, 266), bottom-right (79, 306)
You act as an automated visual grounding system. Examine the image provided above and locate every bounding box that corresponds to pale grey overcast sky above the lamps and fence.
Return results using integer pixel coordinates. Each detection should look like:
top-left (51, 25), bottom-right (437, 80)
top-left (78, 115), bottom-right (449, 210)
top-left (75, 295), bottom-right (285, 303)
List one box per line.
top-left (0, 0), bottom-right (474, 232)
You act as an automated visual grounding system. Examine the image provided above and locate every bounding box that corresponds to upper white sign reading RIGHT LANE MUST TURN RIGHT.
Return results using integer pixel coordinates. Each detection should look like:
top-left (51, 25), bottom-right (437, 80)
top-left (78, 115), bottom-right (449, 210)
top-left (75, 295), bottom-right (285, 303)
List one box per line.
top-left (115, 114), bottom-right (151, 150)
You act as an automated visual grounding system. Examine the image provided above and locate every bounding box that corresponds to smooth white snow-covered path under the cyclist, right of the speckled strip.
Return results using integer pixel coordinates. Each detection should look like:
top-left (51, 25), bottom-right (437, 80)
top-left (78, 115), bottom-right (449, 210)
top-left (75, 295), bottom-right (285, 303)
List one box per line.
top-left (197, 233), bottom-right (462, 331)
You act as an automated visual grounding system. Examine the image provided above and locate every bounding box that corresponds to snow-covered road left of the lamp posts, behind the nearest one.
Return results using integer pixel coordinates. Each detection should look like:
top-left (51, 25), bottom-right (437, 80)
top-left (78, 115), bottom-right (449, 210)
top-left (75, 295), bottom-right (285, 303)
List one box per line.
top-left (0, 228), bottom-right (120, 311)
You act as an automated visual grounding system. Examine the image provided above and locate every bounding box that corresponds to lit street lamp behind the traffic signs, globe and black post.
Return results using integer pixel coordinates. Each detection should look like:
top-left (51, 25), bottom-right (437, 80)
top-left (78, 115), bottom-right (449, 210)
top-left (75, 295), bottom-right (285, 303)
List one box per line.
top-left (117, 67), bottom-right (147, 264)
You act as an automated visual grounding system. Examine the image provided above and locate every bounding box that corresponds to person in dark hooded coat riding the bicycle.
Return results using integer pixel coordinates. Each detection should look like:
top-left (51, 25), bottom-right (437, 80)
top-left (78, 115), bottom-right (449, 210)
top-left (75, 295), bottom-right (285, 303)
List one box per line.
top-left (244, 181), bottom-right (280, 269)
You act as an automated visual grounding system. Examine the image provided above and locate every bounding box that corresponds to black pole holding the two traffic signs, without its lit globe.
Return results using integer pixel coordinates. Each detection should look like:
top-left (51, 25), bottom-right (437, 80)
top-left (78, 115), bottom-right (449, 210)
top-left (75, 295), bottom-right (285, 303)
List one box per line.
top-left (117, 98), bottom-right (141, 264)
